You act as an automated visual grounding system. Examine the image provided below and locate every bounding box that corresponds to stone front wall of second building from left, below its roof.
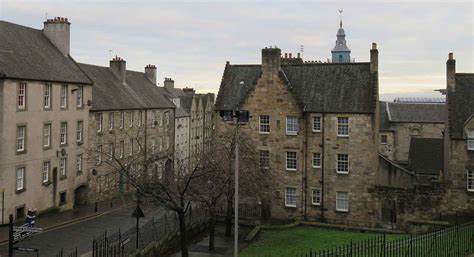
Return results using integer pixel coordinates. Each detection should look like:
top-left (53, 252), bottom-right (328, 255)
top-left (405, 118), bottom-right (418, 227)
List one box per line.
top-left (87, 109), bottom-right (175, 202)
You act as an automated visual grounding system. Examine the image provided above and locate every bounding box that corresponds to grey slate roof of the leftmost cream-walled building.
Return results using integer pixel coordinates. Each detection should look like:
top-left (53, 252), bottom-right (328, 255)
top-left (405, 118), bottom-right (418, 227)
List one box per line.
top-left (0, 21), bottom-right (92, 84)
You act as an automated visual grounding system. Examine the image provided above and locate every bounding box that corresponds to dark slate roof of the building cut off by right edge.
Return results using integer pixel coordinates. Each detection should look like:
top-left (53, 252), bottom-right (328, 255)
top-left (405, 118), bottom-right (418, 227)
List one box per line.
top-left (448, 73), bottom-right (474, 139)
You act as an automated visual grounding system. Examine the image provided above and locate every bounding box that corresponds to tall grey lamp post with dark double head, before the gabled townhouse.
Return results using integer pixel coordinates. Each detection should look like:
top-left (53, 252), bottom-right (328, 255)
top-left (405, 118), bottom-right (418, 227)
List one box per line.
top-left (220, 110), bottom-right (250, 257)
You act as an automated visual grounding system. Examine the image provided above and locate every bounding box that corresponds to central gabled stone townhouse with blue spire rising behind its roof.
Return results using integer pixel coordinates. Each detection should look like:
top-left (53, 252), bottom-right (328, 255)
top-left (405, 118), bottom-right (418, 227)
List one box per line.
top-left (215, 20), bottom-right (380, 221)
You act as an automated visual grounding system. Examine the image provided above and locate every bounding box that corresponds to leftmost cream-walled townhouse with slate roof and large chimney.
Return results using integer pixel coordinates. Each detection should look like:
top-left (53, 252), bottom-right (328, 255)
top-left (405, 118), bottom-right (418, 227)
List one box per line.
top-left (0, 18), bottom-right (92, 223)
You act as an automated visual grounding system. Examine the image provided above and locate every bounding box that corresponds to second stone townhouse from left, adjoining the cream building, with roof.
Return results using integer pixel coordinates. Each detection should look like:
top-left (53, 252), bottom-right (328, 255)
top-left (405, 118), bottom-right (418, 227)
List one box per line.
top-left (79, 57), bottom-right (176, 202)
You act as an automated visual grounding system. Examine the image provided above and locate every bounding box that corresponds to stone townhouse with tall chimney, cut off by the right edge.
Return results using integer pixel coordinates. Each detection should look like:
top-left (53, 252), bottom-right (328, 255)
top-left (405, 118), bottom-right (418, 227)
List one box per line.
top-left (440, 53), bottom-right (474, 214)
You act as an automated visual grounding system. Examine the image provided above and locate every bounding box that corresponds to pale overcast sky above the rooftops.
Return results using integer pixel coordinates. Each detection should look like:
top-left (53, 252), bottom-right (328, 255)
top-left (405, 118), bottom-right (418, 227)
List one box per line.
top-left (0, 0), bottom-right (474, 100)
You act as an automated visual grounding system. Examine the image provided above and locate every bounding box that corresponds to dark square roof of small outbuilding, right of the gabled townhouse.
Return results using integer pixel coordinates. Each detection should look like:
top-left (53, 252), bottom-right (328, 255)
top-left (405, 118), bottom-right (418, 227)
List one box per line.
top-left (408, 138), bottom-right (443, 175)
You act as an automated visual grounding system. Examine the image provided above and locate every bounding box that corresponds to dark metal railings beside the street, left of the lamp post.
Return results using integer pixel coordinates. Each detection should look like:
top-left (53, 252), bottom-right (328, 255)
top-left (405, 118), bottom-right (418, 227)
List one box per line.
top-left (92, 208), bottom-right (209, 257)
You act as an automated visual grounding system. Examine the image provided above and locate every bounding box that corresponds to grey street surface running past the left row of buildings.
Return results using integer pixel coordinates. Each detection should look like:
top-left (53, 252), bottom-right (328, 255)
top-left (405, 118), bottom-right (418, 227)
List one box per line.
top-left (0, 194), bottom-right (164, 257)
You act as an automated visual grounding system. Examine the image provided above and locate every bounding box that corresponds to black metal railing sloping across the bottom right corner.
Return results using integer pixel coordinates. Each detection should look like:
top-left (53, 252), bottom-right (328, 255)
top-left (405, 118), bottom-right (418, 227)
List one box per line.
top-left (299, 222), bottom-right (474, 257)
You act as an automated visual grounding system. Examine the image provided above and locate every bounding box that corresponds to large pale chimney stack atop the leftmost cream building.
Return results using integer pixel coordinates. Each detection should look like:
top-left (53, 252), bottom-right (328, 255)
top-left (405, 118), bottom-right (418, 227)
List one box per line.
top-left (43, 17), bottom-right (71, 56)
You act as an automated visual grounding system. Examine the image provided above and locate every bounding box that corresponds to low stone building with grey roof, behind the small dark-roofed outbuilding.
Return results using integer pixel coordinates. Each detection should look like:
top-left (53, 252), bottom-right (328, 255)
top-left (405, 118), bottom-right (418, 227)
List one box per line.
top-left (379, 98), bottom-right (446, 162)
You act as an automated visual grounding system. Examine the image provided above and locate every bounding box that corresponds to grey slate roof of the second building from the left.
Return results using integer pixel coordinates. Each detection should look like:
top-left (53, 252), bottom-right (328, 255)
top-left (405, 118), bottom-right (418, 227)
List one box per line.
top-left (79, 63), bottom-right (175, 111)
